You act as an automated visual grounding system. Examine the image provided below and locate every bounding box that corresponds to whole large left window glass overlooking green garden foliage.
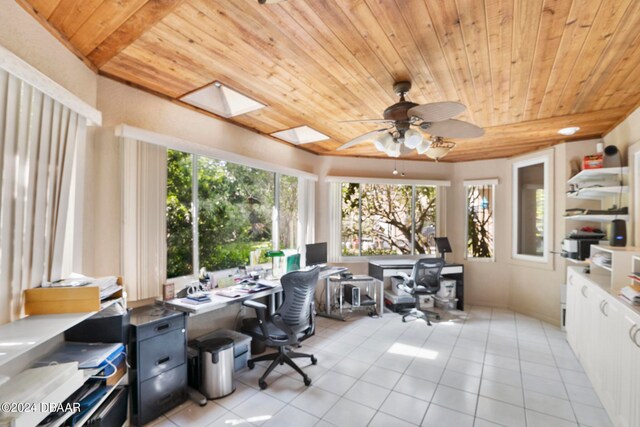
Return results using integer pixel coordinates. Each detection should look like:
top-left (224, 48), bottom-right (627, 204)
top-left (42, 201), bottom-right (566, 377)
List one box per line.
top-left (167, 150), bottom-right (298, 278)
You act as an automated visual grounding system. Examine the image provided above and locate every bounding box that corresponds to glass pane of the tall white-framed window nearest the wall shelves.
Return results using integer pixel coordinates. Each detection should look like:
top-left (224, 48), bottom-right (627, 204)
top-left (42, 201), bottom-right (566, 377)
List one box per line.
top-left (517, 163), bottom-right (545, 256)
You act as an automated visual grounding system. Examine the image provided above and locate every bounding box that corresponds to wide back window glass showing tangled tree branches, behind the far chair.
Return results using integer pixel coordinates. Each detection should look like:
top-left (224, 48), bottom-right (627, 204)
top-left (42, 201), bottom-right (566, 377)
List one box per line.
top-left (341, 183), bottom-right (436, 256)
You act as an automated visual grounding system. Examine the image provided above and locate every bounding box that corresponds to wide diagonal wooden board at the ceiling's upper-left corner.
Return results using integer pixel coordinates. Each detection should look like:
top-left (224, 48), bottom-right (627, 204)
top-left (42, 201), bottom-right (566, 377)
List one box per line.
top-left (69, 0), bottom-right (147, 56)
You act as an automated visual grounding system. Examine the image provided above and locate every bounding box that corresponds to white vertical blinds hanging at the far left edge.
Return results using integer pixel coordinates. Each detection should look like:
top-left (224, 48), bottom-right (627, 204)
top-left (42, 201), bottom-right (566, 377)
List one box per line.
top-left (0, 69), bottom-right (86, 323)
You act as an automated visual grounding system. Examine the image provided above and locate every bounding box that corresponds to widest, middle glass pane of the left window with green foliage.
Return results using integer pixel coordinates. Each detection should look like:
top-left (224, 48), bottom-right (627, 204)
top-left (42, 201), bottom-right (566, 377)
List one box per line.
top-left (198, 157), bottom-right (275, 271)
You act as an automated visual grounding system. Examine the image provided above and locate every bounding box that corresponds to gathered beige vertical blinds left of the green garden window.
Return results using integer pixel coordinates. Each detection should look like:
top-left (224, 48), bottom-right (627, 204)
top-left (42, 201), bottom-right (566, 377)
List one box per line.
top-left (122, 138), bottom-right (167, 301)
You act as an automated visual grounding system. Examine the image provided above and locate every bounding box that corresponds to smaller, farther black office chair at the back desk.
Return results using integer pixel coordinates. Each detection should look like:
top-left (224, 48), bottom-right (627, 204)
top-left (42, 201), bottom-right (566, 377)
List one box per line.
top-left (397, 258), bottom-right (444, 326)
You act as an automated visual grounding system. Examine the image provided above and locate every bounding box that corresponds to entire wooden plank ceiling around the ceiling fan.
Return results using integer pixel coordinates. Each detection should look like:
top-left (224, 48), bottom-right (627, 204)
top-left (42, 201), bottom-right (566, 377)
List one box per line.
top-left (18, 0), bottom-right (640, 161)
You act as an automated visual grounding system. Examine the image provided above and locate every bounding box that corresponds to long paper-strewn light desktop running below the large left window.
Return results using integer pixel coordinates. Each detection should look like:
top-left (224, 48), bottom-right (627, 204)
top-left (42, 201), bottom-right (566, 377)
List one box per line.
top-left (162, 267), bottom-right (347, 316)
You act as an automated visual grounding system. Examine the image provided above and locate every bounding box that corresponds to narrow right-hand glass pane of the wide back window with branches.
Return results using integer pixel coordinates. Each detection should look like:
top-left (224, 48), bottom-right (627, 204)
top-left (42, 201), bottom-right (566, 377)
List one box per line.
top-left (415, 186), bottom-right (437, 254)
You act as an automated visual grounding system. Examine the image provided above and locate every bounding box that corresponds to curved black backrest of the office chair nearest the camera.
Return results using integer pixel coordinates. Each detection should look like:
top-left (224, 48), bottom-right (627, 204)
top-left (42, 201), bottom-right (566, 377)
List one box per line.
top-left (278, 268), bottom-right (320, 333)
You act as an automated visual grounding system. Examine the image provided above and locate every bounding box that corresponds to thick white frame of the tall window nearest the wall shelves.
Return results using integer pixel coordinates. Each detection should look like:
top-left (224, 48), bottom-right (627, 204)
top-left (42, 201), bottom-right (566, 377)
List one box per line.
top-left (511, 152), bottom-right (553, 264)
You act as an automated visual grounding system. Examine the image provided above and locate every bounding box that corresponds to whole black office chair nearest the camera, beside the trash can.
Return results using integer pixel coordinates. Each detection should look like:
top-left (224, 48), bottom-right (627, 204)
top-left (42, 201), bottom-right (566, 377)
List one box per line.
top-left (242, 268), bottom-right (320, 389)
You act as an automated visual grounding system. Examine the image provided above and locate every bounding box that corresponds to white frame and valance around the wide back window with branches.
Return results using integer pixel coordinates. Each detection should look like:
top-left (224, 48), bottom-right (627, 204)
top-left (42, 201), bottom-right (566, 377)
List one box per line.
top-left (326, 176), bottom-right (451, 263)
